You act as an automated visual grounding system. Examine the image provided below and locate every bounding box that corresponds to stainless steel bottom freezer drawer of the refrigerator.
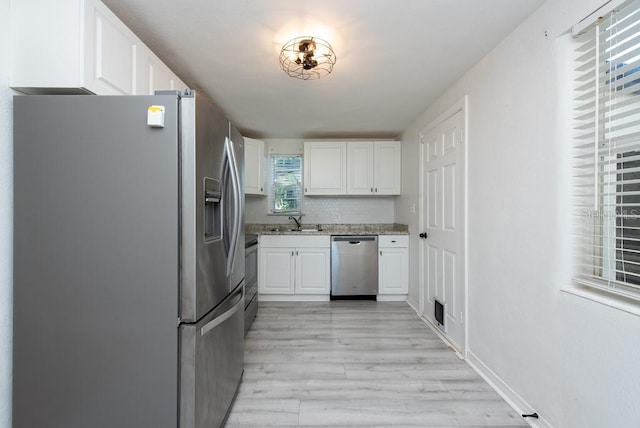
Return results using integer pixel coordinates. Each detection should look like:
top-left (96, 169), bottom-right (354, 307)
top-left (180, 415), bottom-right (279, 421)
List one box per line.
top-left (180, 284), bottom-right (244, 428)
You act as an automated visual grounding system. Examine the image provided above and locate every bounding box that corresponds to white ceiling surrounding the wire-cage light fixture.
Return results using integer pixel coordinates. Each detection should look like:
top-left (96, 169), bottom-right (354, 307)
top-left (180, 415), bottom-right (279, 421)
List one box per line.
top-left (103, 0), bottom-right (543, 138)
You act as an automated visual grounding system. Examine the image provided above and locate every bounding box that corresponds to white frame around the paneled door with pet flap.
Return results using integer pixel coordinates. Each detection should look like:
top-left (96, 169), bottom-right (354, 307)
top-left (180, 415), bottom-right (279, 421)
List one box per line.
top-left (418, 95), bottom-right (469, 359)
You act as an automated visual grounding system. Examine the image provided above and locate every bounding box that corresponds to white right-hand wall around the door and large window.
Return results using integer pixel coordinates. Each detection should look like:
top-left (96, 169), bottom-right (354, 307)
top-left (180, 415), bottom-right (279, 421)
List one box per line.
top-left (395, 0), bottom-right (640, 428)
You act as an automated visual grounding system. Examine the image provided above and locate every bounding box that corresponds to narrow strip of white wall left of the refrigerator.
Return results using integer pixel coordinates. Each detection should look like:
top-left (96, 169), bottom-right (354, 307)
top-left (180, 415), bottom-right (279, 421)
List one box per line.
top-left (0, 0), bottom-right (13, 428)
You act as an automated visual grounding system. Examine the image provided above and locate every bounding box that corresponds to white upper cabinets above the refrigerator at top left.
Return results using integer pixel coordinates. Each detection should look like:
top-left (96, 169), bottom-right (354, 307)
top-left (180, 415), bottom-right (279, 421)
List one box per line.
top-left (10, 0), bottom-right (184, 95)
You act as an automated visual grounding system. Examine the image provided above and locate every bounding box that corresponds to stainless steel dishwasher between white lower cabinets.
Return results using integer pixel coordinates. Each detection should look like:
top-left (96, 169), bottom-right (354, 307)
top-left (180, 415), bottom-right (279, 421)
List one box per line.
top-left (331, 235), bottom-right (378, 298)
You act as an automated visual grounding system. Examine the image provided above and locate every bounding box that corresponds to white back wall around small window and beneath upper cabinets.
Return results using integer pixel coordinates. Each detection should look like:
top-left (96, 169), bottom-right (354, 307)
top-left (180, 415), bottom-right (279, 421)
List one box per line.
top-left (245, 139), bottom-right (394, 224)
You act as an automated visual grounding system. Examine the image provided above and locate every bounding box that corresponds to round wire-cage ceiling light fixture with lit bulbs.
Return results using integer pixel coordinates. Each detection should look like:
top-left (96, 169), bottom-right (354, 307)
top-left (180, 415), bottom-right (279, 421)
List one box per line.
top-left (280, 36), bottom-right (336, 80)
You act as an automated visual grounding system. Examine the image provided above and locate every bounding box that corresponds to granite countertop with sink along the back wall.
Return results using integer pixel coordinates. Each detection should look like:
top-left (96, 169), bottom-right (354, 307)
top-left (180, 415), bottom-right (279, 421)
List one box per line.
top-left (245, 223), bottom-right (409, 235)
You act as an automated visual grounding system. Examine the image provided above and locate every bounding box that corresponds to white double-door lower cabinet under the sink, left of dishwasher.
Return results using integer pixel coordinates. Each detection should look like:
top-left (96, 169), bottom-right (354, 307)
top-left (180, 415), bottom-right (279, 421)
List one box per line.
top-left (258, 235), bottom-right (331, 300)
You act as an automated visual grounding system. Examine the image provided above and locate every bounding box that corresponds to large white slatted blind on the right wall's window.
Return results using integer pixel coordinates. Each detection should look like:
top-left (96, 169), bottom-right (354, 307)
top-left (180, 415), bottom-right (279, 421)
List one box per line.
top-left (573, 0), bottom-right (640, 300)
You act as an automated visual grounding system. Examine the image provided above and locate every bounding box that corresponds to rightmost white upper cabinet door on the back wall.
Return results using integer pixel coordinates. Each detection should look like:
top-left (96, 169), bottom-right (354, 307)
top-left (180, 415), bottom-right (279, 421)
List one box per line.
top-left (374, 141), bottom-right (402, 195)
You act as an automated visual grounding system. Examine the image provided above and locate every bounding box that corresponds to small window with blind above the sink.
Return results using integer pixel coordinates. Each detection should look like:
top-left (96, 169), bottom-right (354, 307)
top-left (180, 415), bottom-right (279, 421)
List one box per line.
top-left (270, 155), bottom-right (302, 213)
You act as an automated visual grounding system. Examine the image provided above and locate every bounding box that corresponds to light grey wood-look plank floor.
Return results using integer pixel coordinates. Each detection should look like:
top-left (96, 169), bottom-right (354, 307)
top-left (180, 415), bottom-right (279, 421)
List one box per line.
top-left (226, 301), bottom-right (527, 428)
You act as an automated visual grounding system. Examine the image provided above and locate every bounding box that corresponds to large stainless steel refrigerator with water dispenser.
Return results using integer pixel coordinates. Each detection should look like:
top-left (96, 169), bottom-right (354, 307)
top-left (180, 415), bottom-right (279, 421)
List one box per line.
top-left (13, 91), bottom-right (244, 428)
